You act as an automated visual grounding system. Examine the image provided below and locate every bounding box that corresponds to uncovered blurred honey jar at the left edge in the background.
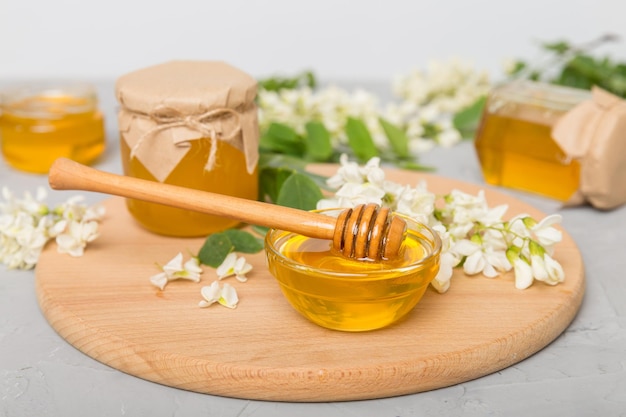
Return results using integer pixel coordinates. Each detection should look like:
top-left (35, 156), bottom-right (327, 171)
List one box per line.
top-left (0, 84), bottom-right (106, 174)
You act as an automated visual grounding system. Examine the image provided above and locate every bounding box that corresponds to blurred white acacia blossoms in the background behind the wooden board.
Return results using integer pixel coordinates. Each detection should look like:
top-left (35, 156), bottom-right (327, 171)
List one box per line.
top-left (258, 60), bottom-right (490, 155)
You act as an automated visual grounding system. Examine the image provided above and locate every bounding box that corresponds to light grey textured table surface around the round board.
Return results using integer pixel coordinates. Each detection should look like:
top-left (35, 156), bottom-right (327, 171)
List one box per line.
top-left (0, 82), bottom-right (626, 417)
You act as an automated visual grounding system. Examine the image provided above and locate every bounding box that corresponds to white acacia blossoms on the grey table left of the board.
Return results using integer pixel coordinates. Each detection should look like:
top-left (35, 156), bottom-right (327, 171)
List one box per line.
top-left (0, 187), bottom-right (104, 269)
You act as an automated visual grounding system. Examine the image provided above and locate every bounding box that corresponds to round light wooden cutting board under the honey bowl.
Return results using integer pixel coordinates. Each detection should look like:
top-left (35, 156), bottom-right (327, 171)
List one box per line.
top-left (36, 166), bottom-right (584, 402)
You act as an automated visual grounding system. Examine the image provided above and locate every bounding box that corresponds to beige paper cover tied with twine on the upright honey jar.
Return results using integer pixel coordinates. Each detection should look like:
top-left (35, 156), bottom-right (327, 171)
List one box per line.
top-left (115, 61), bottom-right (259, 181)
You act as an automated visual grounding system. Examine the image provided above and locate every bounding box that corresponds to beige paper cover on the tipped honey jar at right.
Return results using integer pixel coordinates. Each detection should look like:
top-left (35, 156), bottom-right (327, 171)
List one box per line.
top-left (552, 87), bottom-right (626, 209)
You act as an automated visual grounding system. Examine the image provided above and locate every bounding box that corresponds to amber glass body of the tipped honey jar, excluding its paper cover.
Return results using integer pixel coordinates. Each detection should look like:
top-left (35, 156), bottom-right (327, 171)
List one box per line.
top-left (475, 80), bottom-right (591, 201)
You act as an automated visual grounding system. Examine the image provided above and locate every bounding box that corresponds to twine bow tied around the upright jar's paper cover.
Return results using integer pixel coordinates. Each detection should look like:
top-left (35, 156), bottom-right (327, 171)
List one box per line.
top-left (130, 107), bottom-right (241, 171)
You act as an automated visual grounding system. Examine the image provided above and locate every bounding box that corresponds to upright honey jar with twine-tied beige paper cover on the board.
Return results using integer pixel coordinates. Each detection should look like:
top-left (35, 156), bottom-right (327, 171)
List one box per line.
top-left (116, 61), bottom-right (259, 237)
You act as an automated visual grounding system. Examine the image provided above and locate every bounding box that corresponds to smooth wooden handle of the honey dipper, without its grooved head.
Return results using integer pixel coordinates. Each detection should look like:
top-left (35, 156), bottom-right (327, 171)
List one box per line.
top-left (48, 158), bottom-right (336, 239)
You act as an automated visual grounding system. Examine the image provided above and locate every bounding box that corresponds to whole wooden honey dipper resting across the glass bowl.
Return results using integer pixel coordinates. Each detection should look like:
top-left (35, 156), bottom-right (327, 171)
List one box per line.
top-left (48, 158), bottom-right (406, 260)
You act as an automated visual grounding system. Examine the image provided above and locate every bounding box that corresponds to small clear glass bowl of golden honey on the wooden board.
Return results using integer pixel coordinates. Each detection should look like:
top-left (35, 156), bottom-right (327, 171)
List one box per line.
top-left (265, 209), bottom-right (441, 332)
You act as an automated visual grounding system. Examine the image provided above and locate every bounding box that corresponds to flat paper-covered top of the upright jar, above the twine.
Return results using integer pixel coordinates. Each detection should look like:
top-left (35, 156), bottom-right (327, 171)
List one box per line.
top-left (115, 61), bottom-right (257, 114)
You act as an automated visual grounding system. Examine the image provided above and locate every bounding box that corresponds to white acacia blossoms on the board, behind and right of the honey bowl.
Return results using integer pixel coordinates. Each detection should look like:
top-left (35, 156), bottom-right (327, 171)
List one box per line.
top-left (317, 155), bottom-right (565, 292)
